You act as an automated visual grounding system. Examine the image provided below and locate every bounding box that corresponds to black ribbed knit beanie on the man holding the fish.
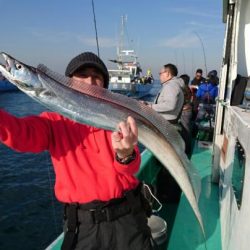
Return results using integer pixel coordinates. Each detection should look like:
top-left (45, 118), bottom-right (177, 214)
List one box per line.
top-left (65, 52), bottom-right (109, 89)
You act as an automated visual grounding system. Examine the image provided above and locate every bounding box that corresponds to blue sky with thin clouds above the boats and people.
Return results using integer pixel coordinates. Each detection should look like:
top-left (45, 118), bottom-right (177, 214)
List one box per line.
top-left (0, 0), bottom-right (225, 79)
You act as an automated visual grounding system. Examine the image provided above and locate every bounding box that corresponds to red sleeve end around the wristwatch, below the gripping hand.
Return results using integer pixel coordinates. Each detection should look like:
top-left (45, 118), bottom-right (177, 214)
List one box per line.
top-left (114, 147), bottom-right (141, 175)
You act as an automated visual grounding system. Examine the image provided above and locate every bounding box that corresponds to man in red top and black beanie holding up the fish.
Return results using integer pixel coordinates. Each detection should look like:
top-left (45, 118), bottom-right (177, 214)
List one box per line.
top-left (0, 52), bottom-right (153, 250)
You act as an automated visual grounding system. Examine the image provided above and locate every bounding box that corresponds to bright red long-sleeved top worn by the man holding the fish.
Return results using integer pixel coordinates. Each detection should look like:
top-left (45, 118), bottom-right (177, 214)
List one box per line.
top-left (0, 110), bottom-right (140, 203)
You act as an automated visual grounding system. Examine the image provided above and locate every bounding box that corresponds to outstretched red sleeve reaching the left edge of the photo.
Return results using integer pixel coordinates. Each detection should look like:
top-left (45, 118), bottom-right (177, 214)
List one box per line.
top-left (0, 110), bottom-right (50, 153)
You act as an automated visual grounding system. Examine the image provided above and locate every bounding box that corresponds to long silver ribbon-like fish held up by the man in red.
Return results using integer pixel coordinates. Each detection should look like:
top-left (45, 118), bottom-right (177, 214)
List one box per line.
top-left (0, 52), bottom-right (205, 235)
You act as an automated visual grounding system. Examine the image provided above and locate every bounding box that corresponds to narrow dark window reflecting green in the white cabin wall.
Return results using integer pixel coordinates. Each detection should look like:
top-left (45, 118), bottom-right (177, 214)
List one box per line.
top-left (232, 140), bottom-right (246, 209)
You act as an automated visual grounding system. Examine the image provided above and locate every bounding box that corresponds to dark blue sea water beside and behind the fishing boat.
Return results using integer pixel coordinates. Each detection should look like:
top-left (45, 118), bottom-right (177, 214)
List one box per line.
top-left (0, 82), bottom-right (160, 250)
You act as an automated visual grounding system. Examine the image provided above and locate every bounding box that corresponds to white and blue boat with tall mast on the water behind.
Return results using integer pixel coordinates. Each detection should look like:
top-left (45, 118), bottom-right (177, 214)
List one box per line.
top-left (109, 16), bottom-right (154, 97)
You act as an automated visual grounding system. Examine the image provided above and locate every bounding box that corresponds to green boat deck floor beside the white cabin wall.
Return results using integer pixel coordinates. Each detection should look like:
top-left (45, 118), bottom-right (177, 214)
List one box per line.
top-left (166, 145), bottom-right (221, 250)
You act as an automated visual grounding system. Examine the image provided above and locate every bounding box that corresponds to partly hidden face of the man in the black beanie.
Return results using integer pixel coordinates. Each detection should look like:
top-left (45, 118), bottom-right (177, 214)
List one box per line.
top-left (72, 68), bottom-right (104, 88)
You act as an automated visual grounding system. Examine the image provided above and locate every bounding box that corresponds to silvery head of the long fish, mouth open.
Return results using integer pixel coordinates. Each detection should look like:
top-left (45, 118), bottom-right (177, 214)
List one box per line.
top-left (0, 52), bottom-right (43, 92)
